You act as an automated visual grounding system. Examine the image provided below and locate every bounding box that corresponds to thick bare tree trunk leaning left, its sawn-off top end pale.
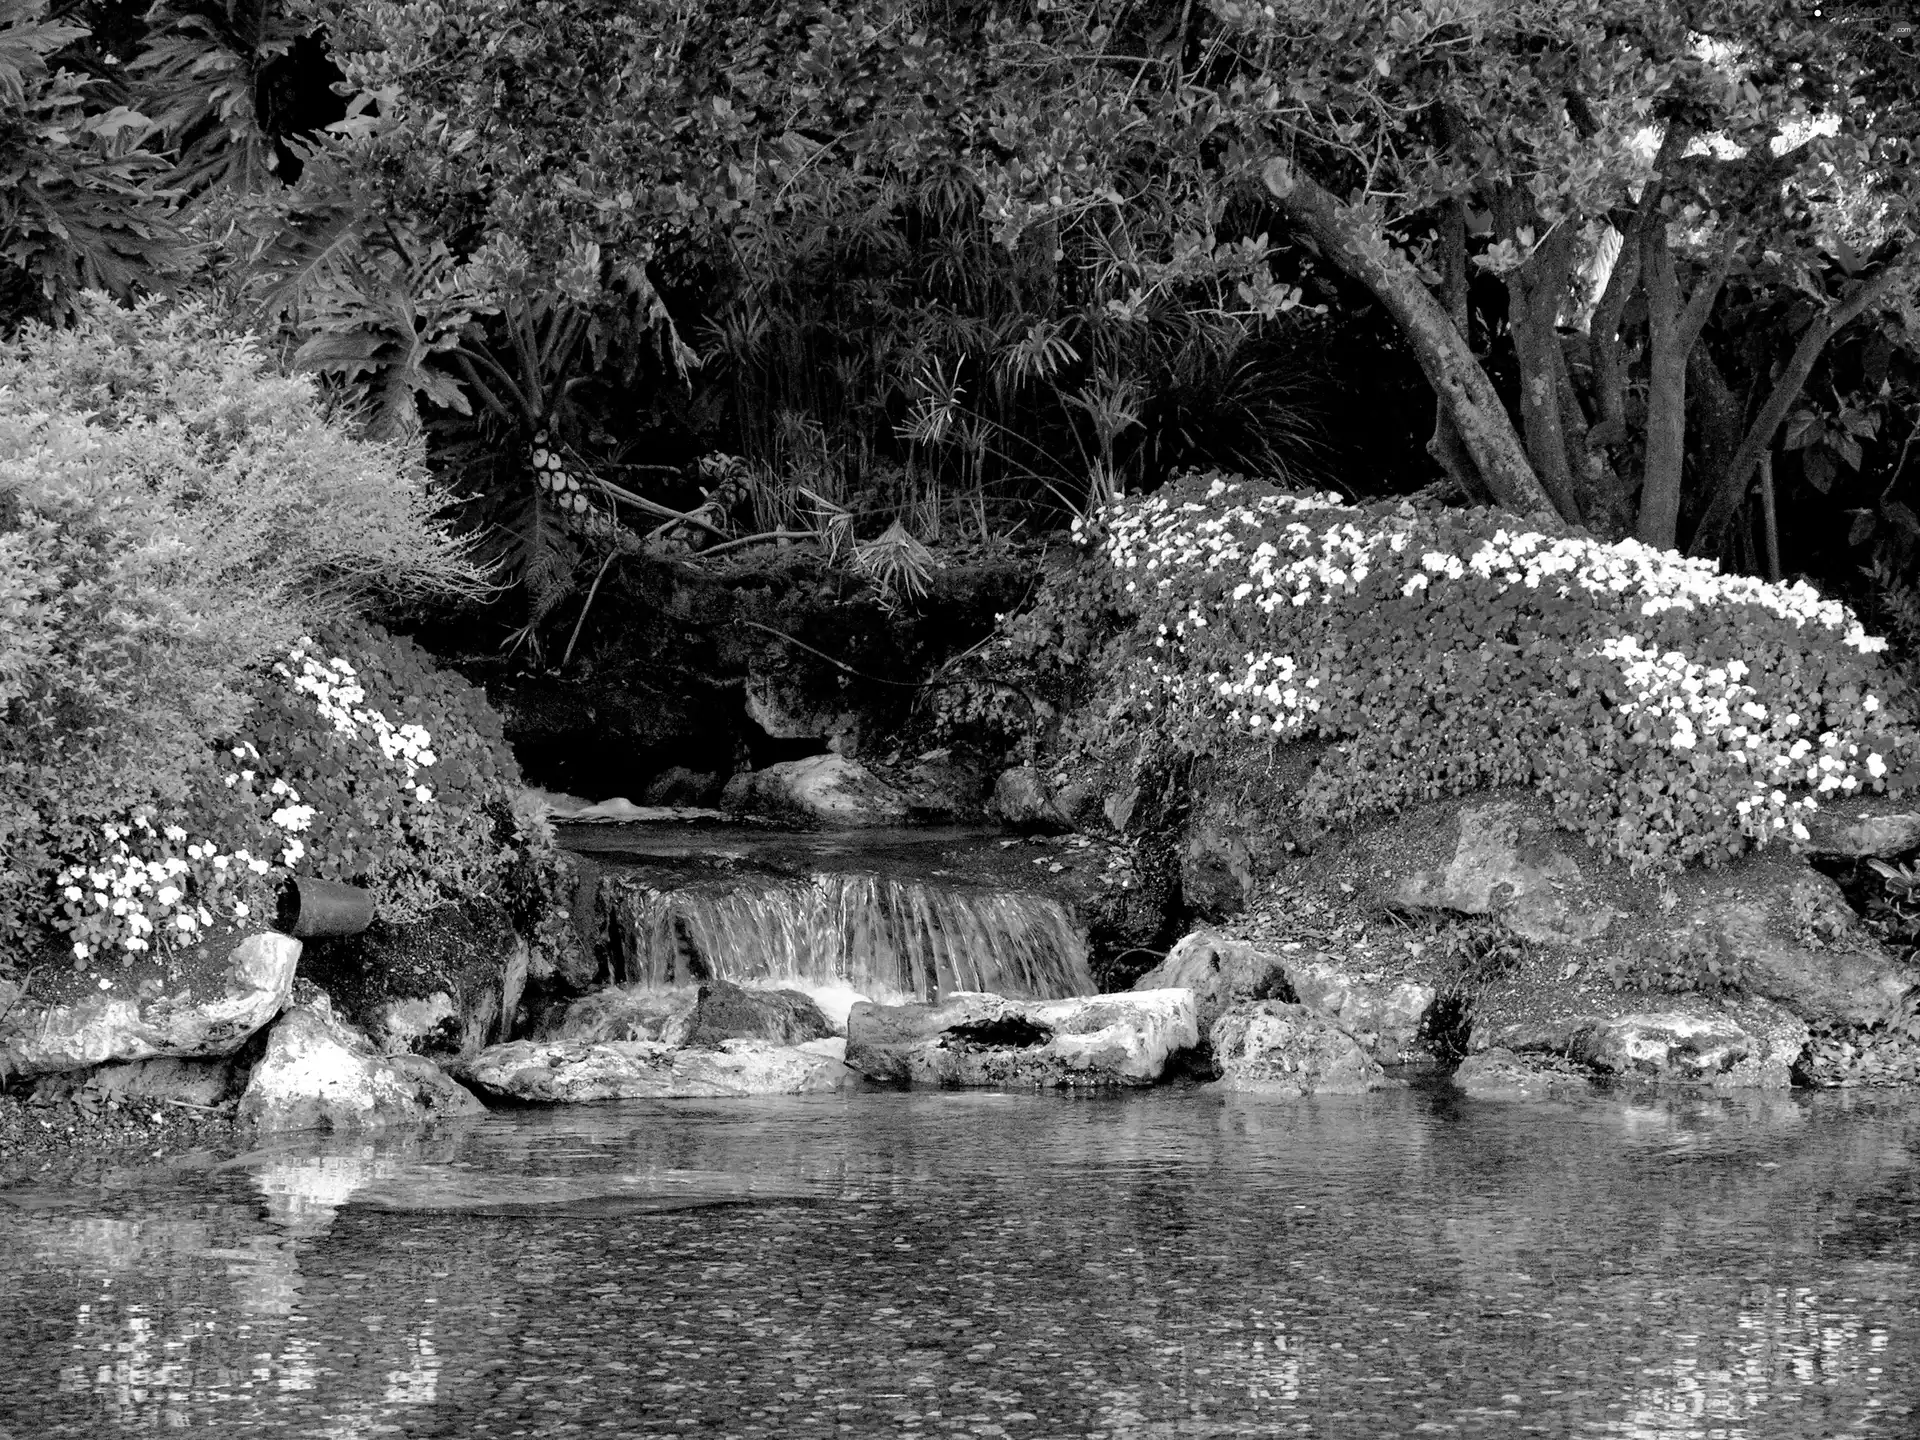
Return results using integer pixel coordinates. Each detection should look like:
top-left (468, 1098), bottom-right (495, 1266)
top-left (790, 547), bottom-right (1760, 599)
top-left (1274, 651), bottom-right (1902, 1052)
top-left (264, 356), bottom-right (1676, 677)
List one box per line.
top-left (1263, 157), bottom-right (1578, 518)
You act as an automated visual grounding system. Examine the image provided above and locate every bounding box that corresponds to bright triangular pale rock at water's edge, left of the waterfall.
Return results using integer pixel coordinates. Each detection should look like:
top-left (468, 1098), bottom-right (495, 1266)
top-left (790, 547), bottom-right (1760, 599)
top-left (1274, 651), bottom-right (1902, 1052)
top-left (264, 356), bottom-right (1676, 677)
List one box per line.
top-left (240, 991), bottom-right (486, 1131)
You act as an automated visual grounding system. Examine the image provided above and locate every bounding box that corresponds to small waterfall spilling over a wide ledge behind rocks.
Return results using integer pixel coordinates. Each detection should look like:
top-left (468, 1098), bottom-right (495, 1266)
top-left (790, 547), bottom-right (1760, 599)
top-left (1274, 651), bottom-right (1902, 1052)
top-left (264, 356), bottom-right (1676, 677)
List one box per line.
top-left (601, 872), bottom-right (1094, 1004)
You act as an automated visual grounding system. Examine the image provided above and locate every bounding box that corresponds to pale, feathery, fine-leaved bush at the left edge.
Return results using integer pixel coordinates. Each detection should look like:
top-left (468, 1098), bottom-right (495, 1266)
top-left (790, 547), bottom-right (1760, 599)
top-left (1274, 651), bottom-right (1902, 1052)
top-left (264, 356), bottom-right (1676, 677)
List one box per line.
top-left (0, 296), bottom-right (484, 971)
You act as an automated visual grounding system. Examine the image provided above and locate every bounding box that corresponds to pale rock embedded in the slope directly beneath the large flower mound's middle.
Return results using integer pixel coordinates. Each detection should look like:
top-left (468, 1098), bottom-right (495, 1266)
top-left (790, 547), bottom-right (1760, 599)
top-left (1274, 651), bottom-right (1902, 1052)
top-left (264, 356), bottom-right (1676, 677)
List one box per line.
top-left (1388, 801), bottom-right (1615, 945)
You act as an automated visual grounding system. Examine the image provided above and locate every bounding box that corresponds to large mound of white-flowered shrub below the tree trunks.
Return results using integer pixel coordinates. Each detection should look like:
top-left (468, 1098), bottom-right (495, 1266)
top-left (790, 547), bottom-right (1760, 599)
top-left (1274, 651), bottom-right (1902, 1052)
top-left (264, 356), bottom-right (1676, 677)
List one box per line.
top-left (1010, 476), bottom-right (1920, 868)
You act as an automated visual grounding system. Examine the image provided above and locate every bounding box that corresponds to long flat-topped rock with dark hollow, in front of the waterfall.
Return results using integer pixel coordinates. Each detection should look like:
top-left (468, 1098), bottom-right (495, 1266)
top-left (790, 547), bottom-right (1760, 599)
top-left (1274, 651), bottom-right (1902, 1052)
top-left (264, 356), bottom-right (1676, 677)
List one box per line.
top-left (847, 989), bottom-right (1200, 1089)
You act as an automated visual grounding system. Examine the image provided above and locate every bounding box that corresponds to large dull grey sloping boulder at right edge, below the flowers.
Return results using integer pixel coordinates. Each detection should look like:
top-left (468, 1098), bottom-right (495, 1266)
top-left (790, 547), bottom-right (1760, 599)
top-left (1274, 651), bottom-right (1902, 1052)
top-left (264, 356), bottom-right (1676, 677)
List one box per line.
top-left (1693, 866), bottom-right (1920, 1025)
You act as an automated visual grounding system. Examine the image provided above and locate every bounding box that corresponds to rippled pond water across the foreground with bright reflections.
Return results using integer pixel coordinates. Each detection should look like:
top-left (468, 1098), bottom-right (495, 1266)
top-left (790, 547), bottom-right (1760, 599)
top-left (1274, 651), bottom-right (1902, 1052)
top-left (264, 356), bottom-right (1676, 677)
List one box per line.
top-left (0, 1085), bottom-right (1920, 1440)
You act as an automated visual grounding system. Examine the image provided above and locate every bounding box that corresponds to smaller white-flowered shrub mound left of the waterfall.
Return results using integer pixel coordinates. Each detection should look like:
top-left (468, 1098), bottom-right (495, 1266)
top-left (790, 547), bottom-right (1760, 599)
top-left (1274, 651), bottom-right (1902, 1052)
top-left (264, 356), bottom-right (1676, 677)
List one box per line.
top-left (43, 622), bottom-right (549, 964)
